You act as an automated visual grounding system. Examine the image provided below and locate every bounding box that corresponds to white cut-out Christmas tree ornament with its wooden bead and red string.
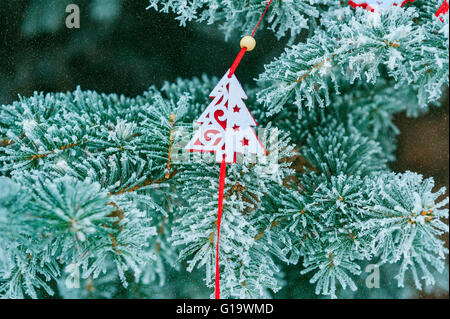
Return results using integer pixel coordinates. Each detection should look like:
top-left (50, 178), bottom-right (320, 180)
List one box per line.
top-left (185, 0), bottom-right (272, 299)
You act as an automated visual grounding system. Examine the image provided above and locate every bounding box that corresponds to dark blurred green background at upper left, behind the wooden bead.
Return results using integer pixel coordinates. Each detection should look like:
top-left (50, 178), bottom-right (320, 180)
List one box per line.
top-left (0, 0), bottom-right (287, 104)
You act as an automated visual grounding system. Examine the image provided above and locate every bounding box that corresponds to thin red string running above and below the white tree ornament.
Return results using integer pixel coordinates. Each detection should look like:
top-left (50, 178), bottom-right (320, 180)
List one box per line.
top-left (215, 0), bottom-right (272, 299)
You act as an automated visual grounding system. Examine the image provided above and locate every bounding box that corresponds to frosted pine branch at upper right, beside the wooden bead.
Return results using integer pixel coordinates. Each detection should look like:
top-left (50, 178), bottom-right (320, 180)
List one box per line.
top-left (258, 2), bottom-right (449, 115)
